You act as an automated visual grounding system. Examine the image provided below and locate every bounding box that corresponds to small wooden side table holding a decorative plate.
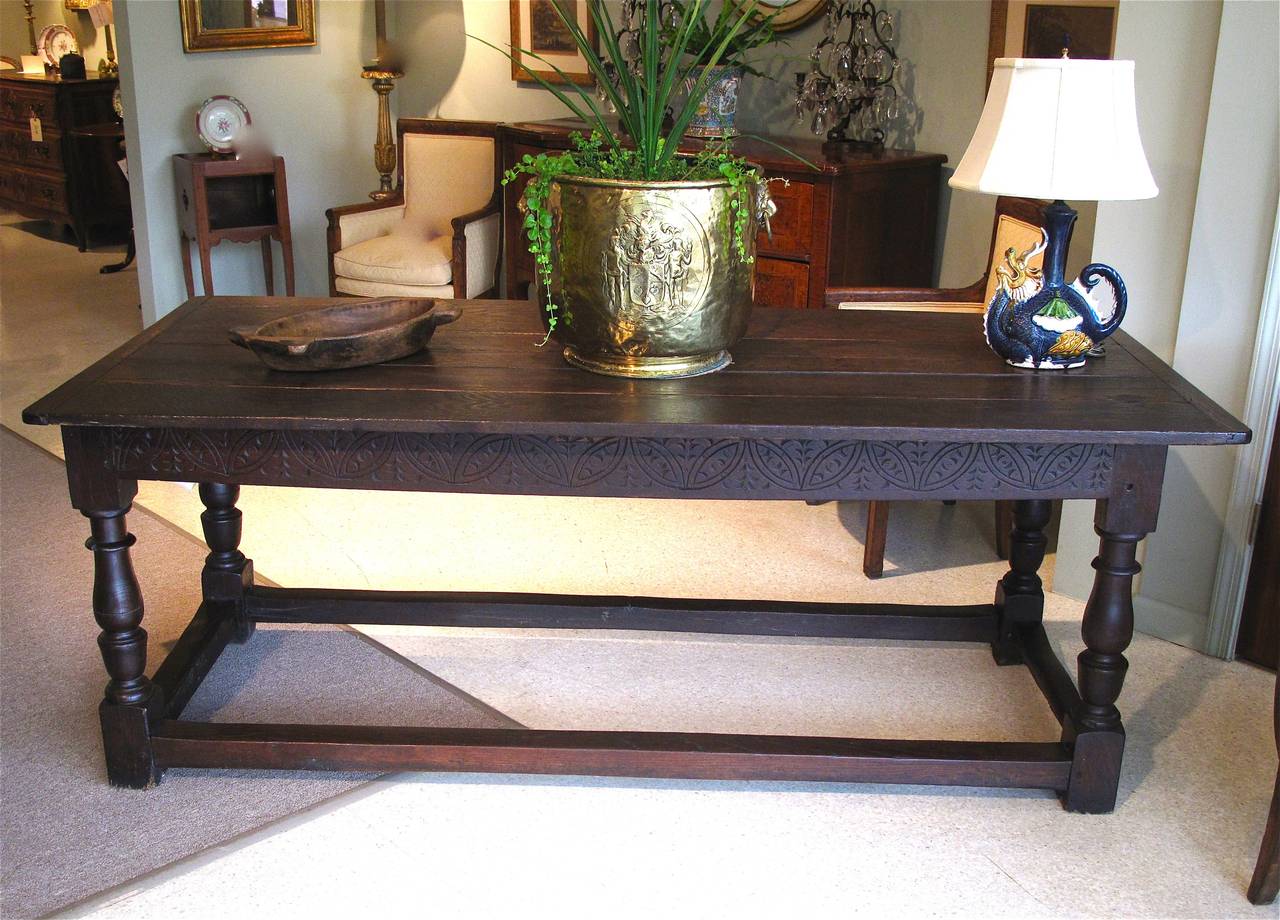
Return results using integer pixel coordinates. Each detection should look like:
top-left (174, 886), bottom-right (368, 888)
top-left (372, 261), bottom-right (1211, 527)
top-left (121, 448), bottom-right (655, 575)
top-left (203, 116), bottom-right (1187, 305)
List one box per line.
top-left (173, 154), bottom-right (293, 297)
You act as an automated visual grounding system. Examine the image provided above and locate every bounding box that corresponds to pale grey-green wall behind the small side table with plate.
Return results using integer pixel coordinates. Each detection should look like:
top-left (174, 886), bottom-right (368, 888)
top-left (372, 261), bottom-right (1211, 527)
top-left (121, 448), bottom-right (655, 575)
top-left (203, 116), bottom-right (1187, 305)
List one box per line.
top-left (117, 0), bottom-right (378, 322)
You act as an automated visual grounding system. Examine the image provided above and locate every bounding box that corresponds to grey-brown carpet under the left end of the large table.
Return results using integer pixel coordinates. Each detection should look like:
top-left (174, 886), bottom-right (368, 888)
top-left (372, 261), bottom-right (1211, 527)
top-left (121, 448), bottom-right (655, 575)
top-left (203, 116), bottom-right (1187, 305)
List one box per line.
top-left (0, 431), bottom-right (511, 917)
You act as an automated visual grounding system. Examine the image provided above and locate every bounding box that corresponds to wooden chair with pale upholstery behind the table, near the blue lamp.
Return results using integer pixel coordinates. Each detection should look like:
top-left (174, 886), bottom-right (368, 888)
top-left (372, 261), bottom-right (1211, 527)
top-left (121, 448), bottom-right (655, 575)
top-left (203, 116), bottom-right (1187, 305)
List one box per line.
top-left (824, 197), bottom-right (1044, 578)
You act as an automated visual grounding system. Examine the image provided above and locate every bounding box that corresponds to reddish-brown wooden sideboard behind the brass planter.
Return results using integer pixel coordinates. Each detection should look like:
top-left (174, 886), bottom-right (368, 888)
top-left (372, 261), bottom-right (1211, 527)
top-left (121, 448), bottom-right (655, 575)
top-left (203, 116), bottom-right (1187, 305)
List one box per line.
top-left (498, 119), bottom-right (946, 310)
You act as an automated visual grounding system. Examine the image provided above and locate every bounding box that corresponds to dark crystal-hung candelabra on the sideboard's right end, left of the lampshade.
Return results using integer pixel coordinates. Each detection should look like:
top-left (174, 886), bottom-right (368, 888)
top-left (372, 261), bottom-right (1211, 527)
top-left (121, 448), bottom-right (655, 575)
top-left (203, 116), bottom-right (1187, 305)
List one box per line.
top-left (796, 0), bottom-right (908, 147)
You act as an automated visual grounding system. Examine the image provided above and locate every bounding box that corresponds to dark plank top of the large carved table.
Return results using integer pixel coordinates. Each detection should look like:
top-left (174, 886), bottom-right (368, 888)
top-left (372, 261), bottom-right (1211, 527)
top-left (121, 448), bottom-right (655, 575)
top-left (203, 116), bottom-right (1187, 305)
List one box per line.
top-left (23, 297), bottom-right (1249, 444)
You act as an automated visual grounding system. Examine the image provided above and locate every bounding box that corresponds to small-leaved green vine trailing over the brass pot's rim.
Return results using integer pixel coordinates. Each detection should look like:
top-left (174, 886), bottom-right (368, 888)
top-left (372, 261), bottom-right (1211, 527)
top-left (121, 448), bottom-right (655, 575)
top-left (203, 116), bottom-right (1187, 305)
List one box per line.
top-left (502, 132), bottom-right (764, 344)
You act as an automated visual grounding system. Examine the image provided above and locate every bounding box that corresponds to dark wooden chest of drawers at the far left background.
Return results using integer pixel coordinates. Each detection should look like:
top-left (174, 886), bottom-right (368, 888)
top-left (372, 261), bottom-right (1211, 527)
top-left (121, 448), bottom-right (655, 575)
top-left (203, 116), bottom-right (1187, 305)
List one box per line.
top-left (0, 73), bottom-right (120, 252)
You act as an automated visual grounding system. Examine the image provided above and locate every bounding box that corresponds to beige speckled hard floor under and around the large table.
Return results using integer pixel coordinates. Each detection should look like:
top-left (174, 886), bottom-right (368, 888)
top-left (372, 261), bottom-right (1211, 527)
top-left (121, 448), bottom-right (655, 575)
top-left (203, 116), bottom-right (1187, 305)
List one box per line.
top-left (0, 211), bottom-right (1275, 917)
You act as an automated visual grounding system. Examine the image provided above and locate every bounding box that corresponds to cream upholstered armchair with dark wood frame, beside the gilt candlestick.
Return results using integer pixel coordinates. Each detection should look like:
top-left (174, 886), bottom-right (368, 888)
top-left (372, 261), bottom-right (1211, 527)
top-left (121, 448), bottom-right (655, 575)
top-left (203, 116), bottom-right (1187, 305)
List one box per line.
top-left (325, 118), bottom-right (502, 298)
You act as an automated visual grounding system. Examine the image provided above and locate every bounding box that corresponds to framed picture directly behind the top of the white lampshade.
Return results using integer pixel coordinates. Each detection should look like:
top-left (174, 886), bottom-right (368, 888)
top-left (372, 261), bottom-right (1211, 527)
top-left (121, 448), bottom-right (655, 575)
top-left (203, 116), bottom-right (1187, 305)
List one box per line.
top-left (987, 0), bottom-right (1120, 86)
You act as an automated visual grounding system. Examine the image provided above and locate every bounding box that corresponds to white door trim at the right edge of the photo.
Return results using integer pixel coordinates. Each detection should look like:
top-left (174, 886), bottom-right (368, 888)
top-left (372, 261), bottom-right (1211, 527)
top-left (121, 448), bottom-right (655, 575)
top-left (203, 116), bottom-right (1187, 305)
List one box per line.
top-left (1206, 201), bottom-right (1280, 662)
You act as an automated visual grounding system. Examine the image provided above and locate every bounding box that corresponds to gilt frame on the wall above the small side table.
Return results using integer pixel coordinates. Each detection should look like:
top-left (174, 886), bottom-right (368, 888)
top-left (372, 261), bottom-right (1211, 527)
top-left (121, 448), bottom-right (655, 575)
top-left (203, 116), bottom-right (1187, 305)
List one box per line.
top-left (178, 0), bottom-right (316, 54)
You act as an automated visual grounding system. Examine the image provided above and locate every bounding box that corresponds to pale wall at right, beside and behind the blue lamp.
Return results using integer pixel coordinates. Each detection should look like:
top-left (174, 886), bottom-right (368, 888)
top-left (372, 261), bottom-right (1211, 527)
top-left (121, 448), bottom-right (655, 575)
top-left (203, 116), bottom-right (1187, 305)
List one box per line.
top-left (1055, 0), bottom-right (1280, 647)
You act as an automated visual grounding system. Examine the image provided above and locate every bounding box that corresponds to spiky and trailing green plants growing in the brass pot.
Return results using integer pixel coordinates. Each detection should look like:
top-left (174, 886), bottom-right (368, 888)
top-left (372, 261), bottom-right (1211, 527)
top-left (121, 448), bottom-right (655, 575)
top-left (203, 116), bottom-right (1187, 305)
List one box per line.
top-left (471, 0), bottom-right (783, 335)
